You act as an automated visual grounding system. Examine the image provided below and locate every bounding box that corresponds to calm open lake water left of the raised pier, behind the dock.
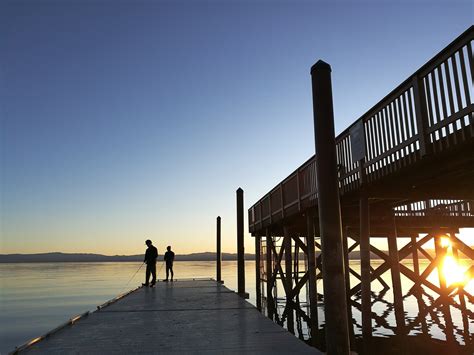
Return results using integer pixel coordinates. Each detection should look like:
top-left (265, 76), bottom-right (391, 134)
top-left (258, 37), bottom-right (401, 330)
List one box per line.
top-left (0, 261), bottom-right (255, 354)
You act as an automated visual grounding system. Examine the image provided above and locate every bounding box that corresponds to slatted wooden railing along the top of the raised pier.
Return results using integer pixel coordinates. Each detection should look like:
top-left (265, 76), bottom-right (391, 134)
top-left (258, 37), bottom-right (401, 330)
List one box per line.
top-left (249, 26), bottom-right (474, 232)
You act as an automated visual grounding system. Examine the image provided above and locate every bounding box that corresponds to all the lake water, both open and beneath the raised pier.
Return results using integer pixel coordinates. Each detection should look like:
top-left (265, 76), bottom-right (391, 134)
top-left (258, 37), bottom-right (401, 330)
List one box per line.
top-left (0, 260), bottom-right (474, 354)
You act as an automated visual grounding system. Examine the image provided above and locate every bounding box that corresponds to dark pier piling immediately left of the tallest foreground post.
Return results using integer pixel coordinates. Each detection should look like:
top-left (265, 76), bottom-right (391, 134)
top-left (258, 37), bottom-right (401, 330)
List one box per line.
top-left (306, 212), bottom-right (319, 347)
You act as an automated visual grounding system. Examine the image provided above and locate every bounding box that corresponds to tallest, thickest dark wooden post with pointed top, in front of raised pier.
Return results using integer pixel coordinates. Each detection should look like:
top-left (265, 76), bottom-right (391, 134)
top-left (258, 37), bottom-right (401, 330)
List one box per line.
top-left (311, 60), bottom-right (350, 355)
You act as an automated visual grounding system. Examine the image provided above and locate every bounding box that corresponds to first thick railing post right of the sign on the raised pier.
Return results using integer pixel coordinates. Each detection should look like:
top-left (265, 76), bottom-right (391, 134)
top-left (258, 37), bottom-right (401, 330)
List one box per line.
top-left (413, 75), bottom-right (433, 156)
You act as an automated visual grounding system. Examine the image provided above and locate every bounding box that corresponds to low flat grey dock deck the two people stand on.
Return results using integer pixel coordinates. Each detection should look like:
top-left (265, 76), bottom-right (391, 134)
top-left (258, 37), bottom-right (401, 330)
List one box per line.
top-left (22, 280), bottom-right (318, 354)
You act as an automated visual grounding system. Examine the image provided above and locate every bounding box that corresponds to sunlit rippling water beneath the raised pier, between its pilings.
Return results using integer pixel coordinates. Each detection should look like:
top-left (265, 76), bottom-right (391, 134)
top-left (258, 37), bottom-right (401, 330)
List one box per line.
top-left (263, 260), bottom-right (474, 354)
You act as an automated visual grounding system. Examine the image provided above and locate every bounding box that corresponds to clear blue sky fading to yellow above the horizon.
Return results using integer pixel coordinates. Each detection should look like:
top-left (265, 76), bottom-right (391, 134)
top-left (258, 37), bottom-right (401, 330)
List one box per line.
top-left (0, 0), bottom-right (473, 255)
